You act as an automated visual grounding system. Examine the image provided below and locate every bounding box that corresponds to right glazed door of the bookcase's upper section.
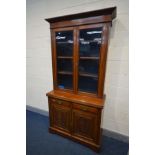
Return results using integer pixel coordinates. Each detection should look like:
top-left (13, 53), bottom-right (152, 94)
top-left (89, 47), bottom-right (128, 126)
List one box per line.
top-left (78, 24), bottom-right (103, 94)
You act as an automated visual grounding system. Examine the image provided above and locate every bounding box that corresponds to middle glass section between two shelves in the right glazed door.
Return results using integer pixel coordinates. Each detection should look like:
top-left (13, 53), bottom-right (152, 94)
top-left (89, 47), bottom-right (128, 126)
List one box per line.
top-left (79, 60), bottom-right (98, 75)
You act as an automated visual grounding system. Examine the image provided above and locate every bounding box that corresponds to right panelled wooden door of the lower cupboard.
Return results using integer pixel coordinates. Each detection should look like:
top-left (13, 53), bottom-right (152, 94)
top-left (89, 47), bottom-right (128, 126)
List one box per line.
top-left (72, 109), bottom-right (97, 142)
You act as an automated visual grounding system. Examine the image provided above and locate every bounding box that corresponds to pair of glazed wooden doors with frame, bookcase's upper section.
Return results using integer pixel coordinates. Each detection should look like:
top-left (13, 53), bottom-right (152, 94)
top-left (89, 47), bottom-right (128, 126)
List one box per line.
top-left (52, 24), bottom-right (109, 97)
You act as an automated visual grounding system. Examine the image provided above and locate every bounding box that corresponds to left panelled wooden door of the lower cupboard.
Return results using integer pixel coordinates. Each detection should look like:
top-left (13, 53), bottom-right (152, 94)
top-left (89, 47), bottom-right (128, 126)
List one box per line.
top-left (51, 104), bottom-right (71, 133)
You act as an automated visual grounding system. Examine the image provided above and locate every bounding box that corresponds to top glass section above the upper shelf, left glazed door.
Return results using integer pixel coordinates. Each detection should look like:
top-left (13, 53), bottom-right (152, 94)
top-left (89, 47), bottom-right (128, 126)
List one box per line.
top-left (56, 31), bottom-right (73, 56)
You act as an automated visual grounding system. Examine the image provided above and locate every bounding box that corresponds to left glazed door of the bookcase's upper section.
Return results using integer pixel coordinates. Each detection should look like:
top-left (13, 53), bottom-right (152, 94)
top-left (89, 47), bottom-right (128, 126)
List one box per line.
top-left (52, 28), bottom-right (75, 91)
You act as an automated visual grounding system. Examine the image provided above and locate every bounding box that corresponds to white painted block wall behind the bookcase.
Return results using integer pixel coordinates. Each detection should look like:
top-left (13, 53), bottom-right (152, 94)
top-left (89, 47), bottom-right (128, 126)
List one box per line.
top-left (26, 0), bottom-right (129, 135)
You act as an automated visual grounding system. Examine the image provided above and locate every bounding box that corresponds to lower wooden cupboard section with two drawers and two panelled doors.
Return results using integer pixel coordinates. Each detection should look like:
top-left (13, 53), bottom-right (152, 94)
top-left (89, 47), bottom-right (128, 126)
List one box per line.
top-left (49, 98), bottom-right (101, 151)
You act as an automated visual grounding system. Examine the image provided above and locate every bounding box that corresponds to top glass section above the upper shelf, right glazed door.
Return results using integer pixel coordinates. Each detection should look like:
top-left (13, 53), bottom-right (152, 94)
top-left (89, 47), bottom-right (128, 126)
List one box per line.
top-left (79, 27), bottom-right (102, 57)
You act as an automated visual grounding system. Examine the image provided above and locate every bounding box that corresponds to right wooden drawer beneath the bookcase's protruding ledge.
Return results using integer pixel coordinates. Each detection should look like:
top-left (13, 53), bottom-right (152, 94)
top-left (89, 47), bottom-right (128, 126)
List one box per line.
top-left (73, 104), bottom-right (98, 113)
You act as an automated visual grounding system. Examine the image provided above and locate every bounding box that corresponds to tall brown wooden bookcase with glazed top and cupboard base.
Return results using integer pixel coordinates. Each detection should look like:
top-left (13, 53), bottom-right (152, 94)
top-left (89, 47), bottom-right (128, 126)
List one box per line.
top-left (46, 7), bottom-right (116, 151)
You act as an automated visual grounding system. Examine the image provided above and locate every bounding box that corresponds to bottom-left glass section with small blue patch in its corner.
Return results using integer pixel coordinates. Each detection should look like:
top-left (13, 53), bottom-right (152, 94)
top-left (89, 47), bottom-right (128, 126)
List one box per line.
top-left (58, 74), bottom-right (73, 89)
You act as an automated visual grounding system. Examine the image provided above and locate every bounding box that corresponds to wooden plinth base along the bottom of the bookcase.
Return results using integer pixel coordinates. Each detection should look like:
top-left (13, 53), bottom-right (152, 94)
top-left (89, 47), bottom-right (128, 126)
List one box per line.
top-left (49, 127), bottom-right (100, 152)
